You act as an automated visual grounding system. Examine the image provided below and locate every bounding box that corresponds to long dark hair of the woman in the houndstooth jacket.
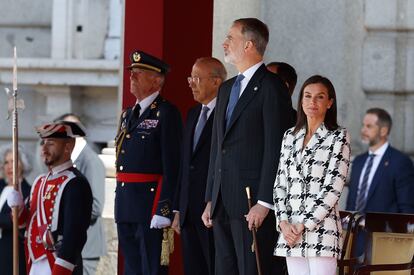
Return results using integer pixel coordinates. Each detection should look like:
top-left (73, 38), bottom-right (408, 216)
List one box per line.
top-left (293, 75), bottom-right (339, 134)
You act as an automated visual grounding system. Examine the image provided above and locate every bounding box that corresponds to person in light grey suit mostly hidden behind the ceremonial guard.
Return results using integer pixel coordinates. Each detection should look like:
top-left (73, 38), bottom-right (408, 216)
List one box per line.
top-left (55, 113), bottom-right (106, 275)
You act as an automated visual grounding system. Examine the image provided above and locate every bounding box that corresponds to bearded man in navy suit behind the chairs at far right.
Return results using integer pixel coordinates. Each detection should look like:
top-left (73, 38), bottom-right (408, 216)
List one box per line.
top-left (346, 108), bottom-right (414, 213)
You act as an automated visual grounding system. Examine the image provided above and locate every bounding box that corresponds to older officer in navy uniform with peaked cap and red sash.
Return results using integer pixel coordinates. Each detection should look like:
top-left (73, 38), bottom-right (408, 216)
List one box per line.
top-left (115, 51), bottom-right (182, 275)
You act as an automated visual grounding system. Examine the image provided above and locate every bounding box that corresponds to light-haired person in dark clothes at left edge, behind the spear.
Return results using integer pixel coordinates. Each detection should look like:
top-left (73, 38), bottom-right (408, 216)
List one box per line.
top-left (0, 145), bottom-right (32, 275)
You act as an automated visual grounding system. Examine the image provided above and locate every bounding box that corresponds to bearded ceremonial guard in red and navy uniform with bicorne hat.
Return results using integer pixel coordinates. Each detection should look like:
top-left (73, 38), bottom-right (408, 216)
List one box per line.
top-left (7, 121), bottom-right (92, 275)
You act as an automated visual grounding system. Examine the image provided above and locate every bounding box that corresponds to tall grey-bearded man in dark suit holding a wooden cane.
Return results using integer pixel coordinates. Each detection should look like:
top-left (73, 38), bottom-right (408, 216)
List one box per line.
top-left (202, 18), bottom-right (293, 275)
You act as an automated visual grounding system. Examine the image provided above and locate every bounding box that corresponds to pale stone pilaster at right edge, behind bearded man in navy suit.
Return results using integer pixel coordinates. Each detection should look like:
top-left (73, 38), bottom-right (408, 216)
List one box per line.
top-left (362, 0), bottom-right (414, 155)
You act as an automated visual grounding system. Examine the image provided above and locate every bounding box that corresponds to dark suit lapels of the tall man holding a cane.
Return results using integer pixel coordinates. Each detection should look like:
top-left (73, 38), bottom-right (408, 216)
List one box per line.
top-left (224, 65), bottom-right (267, 138)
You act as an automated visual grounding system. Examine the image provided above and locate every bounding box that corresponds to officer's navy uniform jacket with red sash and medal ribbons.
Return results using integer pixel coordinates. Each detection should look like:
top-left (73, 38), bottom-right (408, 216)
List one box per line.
top-left (115, 96), bottom-right (182, 224)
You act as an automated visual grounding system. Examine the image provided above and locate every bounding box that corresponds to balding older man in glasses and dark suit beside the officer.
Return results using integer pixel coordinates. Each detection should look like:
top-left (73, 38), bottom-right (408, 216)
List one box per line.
top-left (172, 57), bottom-right (227, 275)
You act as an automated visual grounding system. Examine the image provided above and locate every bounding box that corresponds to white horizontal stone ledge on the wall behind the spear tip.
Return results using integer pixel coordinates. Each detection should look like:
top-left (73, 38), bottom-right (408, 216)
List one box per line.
top-left (0, 58), bottom-right (120, 87)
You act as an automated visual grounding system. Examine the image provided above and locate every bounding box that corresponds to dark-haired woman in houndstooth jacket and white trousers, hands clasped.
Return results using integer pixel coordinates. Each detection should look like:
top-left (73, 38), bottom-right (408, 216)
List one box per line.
top-left (273, 75), bottom-right (350, 275)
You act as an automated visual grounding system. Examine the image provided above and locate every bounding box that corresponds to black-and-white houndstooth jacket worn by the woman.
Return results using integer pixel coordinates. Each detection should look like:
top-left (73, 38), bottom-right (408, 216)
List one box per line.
top-left (273, 123), bottom-right (351, 258)
